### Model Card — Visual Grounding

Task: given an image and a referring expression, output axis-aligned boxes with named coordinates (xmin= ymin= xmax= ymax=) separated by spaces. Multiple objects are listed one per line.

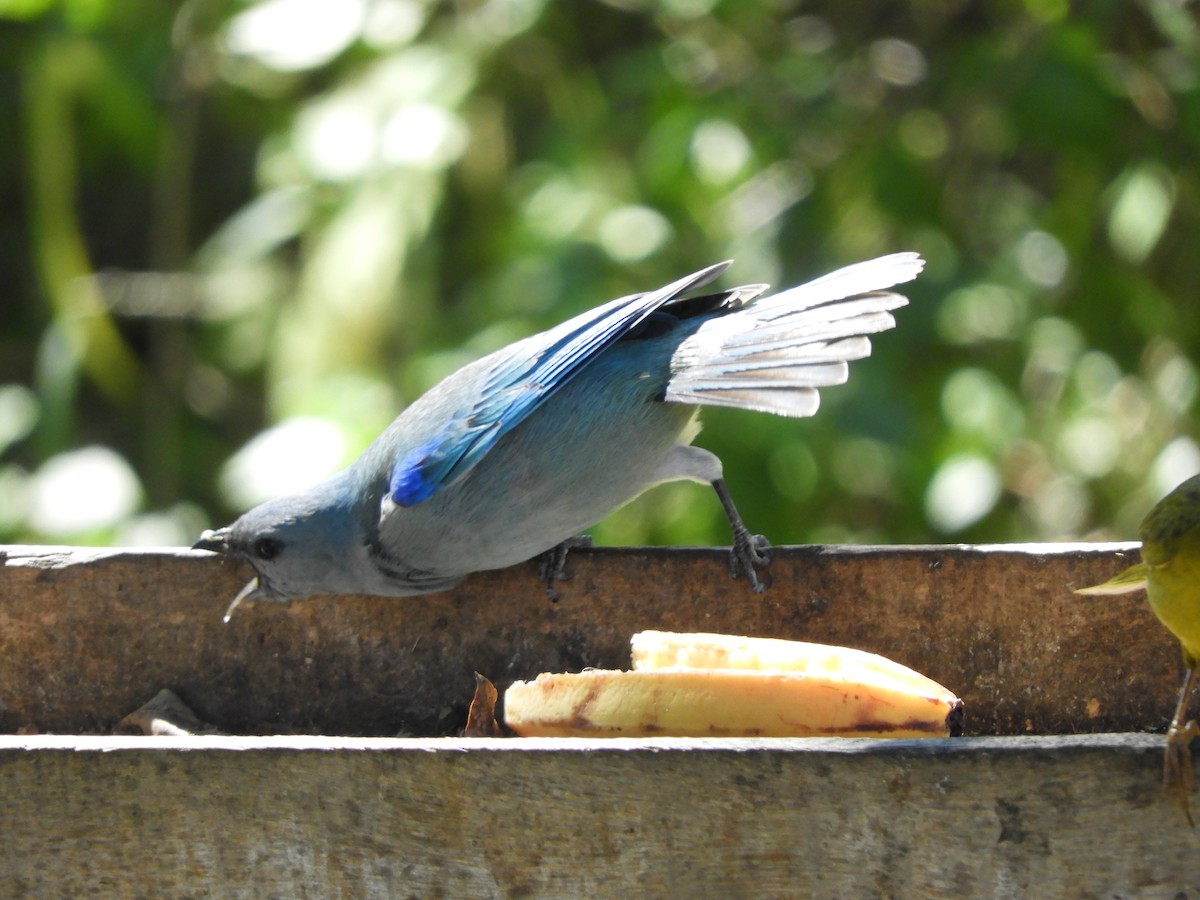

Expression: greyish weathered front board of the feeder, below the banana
xmin=0 ymin=734 xmax=1200 ymax=898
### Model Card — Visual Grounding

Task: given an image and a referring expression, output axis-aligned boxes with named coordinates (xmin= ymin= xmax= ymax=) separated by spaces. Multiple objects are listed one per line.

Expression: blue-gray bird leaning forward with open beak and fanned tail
xmin=196 ymin=253 xmax=924 ymax=611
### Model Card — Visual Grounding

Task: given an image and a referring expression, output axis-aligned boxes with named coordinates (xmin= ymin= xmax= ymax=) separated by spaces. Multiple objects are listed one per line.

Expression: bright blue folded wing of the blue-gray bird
xmin=389 ymin=263 xmax=728 ymax=506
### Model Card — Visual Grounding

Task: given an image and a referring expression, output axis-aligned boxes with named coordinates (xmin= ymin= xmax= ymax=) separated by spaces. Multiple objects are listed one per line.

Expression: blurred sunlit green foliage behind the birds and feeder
xmin=0 ymin=0 xmax=1200 ymax=545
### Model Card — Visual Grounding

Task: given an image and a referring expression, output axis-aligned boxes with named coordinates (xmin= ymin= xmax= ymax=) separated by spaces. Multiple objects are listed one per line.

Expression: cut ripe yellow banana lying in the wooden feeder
xmin=504 ymin=631 xmax=962 ymax=738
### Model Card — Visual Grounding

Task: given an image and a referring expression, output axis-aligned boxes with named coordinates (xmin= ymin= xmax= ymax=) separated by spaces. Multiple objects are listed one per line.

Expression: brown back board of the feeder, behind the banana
xmin=0 ymin=545 xmax=1178 ymax=736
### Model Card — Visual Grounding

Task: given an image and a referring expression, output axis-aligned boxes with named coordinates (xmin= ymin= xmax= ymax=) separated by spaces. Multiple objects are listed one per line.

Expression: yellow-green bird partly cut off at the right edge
xmin=1075 ymin=475 xmax=1200 ymax=827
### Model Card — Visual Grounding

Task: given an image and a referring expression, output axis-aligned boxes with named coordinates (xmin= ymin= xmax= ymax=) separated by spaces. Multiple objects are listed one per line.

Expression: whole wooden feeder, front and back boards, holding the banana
xmin=0 ymin=545 xmax=1200 ymax=898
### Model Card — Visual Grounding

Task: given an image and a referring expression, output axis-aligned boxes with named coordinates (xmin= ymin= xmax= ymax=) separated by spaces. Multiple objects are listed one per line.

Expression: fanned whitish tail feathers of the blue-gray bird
xmin=664 ymin=253 xmax=924 ymax=416
